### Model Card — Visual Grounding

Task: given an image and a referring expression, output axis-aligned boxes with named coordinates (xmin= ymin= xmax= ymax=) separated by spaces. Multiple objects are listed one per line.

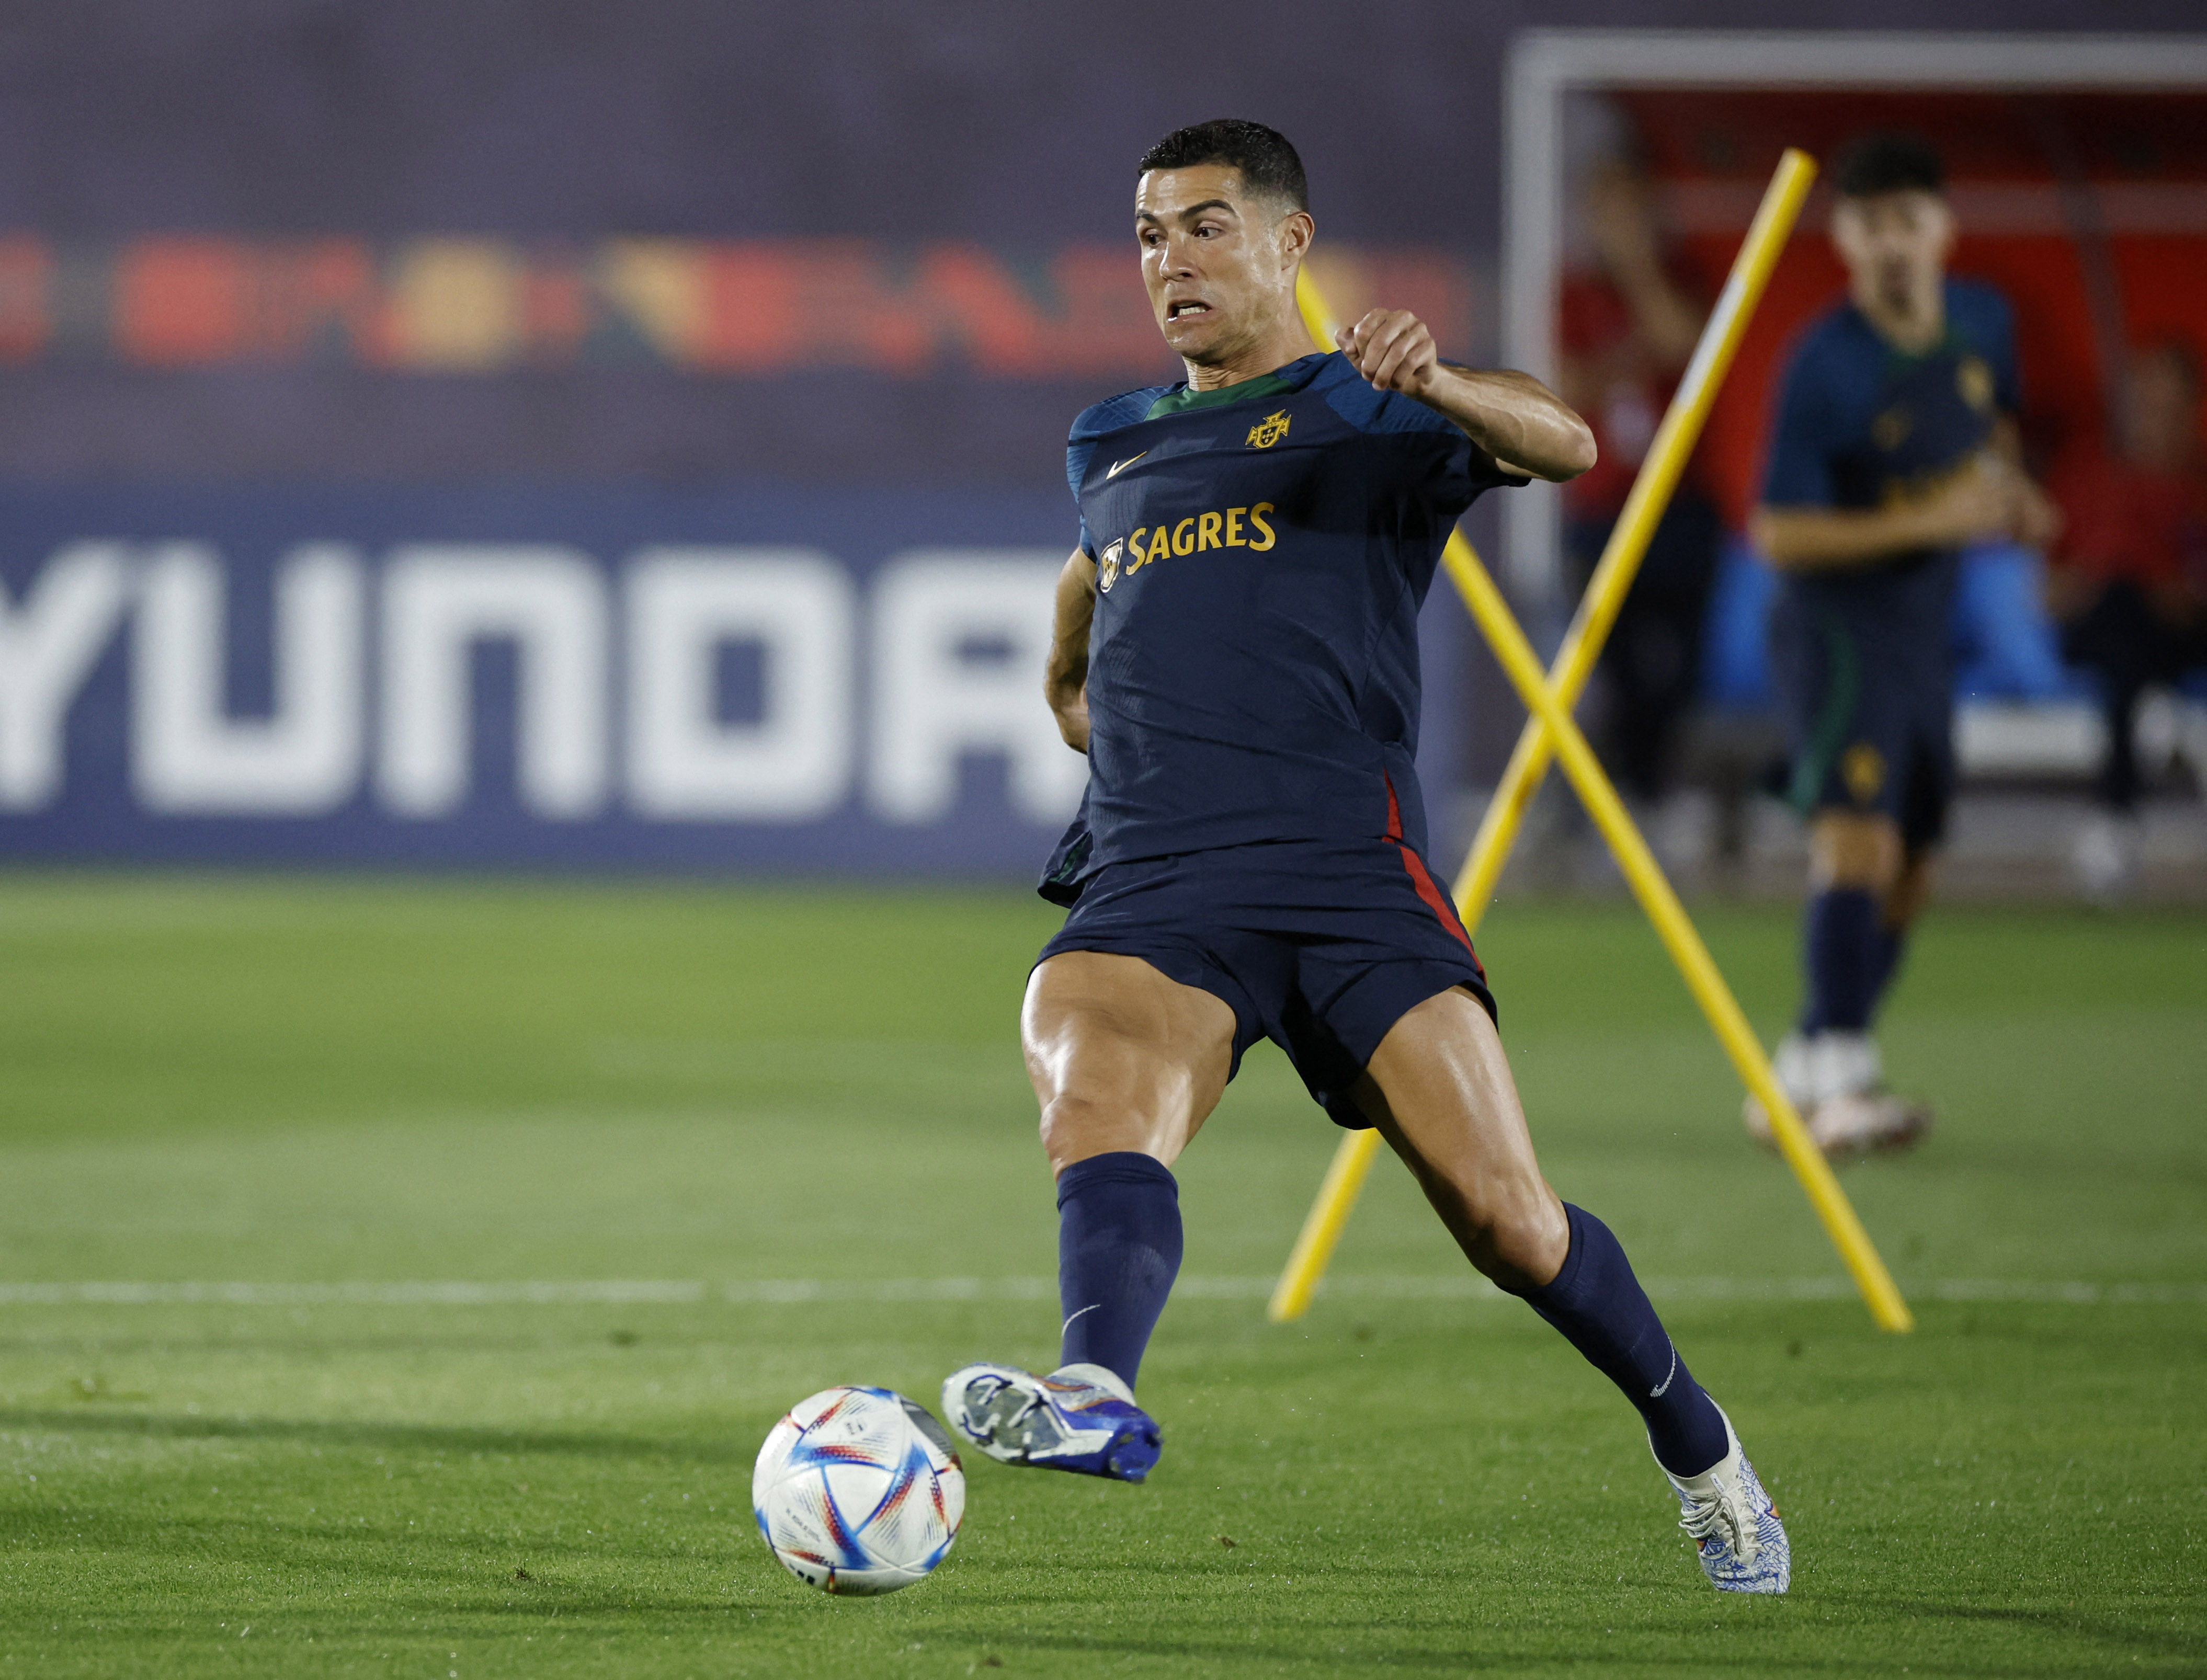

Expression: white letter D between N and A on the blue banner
xmin=624 ymin=547 xmax=854 ymax=821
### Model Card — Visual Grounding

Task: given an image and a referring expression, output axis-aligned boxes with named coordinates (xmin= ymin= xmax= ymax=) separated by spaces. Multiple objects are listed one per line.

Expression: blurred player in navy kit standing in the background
xmin=1746 ymin=135 xmax=2055 ymax=1155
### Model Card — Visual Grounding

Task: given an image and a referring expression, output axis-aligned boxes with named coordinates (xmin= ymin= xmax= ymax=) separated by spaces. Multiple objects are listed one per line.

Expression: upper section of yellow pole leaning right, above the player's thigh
xmin=1457 ymin=148 xmax=1816 ymax=927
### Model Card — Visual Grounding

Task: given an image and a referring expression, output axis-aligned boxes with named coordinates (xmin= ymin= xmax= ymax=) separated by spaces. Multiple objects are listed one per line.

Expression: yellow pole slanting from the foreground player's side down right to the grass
xmin=1443 ymin=541 xmax=1916 ymax=1331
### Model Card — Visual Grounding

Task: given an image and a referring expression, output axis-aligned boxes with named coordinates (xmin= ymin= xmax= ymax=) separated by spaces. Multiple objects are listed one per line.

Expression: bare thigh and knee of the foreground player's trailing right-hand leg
xmin=1357 ymin=989 xmax=1572 ymax=1287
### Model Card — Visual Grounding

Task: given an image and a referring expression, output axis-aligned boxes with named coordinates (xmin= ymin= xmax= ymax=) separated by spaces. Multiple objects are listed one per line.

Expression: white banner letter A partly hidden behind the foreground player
xmin=867 ymin=547 xmax=1088 ymax=824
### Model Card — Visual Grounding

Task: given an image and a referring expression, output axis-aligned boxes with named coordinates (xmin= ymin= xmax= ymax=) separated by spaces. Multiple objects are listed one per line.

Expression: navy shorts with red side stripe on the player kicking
xmin=1037 ymin=839 xmax=1494 ymax=1128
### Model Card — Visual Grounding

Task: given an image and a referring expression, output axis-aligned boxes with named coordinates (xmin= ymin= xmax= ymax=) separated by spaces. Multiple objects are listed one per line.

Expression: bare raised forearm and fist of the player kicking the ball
xmin=1342 ymin=309 xmax=1594 ymax=484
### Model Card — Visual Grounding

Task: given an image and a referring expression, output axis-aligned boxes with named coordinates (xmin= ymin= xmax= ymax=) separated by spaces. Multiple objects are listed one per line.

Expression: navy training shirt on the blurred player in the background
xmin=1764 ymin=278 xmax=2017 ymax=563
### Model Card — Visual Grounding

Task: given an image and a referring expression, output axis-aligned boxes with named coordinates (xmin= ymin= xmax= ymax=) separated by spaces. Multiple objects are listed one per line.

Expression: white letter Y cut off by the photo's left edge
xmin=0 ymin=543 xmax=130 ymax=810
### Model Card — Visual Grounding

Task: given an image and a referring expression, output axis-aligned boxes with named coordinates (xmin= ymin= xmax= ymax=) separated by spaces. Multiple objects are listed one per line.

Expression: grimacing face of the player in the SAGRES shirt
xmin=1134 ymin=163 xmax=1311 ymax=367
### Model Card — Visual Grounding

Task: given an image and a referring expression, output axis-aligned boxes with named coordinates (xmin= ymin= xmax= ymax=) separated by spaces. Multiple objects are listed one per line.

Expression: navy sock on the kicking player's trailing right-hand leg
xmin=1525 ymin=1203 xmax=1726 ymax=1477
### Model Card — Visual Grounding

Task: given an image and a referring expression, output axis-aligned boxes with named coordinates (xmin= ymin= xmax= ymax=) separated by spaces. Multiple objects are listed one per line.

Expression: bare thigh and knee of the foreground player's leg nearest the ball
xmin=1020 ymin=952 xmax=1234 ymax=1172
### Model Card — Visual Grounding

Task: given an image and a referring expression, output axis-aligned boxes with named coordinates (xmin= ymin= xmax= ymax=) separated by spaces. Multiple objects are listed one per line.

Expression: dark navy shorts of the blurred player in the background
xmin=1770 ymin=574 xmax=1955 ymax=852
